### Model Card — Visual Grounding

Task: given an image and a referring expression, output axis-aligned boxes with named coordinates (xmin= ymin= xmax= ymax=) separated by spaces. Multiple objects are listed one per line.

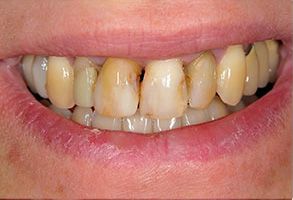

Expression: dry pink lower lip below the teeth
xmin=0 ymin=54 xmax=292 ymax=163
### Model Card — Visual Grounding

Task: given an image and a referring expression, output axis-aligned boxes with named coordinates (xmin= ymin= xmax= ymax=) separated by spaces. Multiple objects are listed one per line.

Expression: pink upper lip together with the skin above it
xmin=0 ymin=1 xmax=291 ymax=59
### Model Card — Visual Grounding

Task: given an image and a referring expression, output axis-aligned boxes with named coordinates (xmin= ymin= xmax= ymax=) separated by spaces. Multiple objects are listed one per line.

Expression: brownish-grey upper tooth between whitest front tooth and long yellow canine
xmin=185 ymin=52 xmax=217 ymax=109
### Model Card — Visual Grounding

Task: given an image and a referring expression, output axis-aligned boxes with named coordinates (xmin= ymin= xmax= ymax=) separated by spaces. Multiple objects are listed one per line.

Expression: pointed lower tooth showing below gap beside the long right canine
xmin=208 ymin=96 xmax=229 ymax=120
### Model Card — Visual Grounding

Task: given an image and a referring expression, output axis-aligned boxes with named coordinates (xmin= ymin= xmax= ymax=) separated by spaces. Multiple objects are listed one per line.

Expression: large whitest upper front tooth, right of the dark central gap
xmin=139 ymin=59 xmax=187 ymax=119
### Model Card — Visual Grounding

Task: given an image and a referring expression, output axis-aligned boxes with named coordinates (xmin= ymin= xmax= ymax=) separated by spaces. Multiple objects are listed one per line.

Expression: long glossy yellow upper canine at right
xmin=217 ymin=45 xmax=246 ymax=105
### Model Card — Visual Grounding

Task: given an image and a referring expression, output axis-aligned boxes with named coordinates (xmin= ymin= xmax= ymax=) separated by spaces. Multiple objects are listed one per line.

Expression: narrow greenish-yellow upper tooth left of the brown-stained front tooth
xmin=73 ymin=57 xmax=98 ymax=107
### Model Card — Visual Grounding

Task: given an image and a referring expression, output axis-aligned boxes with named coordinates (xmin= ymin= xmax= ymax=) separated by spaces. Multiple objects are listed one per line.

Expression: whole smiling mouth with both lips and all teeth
xmin=0 ymin=0 xmax=292 ymax=162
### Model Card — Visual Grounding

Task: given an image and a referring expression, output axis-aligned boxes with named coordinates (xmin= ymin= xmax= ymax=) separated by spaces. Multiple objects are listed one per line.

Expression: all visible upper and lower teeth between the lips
xmin=21 ymin=40 xmax=280 ymax=134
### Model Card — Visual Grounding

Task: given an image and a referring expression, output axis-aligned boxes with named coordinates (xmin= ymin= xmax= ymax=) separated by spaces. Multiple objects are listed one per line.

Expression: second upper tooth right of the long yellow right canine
xmin=254 ymin=42 xmax=270 ymax=88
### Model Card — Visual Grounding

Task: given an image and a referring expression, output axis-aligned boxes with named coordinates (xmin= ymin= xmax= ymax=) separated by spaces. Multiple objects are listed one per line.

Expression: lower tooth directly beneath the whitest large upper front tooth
xmin=153 ymin=117 xmax=181 ymax=132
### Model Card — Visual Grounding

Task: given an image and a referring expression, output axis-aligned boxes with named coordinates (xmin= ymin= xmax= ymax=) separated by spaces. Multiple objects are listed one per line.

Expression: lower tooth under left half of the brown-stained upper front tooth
xmin=92 ymin=111 xmax=122 ymax=131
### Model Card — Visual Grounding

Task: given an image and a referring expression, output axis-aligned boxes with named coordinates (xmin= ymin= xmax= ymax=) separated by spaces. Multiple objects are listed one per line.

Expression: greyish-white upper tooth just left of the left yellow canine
xmin=32 ymin=56 xmax=48 ymax=98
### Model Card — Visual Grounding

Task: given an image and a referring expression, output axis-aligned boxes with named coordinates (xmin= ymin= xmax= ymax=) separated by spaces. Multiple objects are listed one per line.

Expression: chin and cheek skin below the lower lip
xmin=0 ymin=105 xmax=292 ymax=198
